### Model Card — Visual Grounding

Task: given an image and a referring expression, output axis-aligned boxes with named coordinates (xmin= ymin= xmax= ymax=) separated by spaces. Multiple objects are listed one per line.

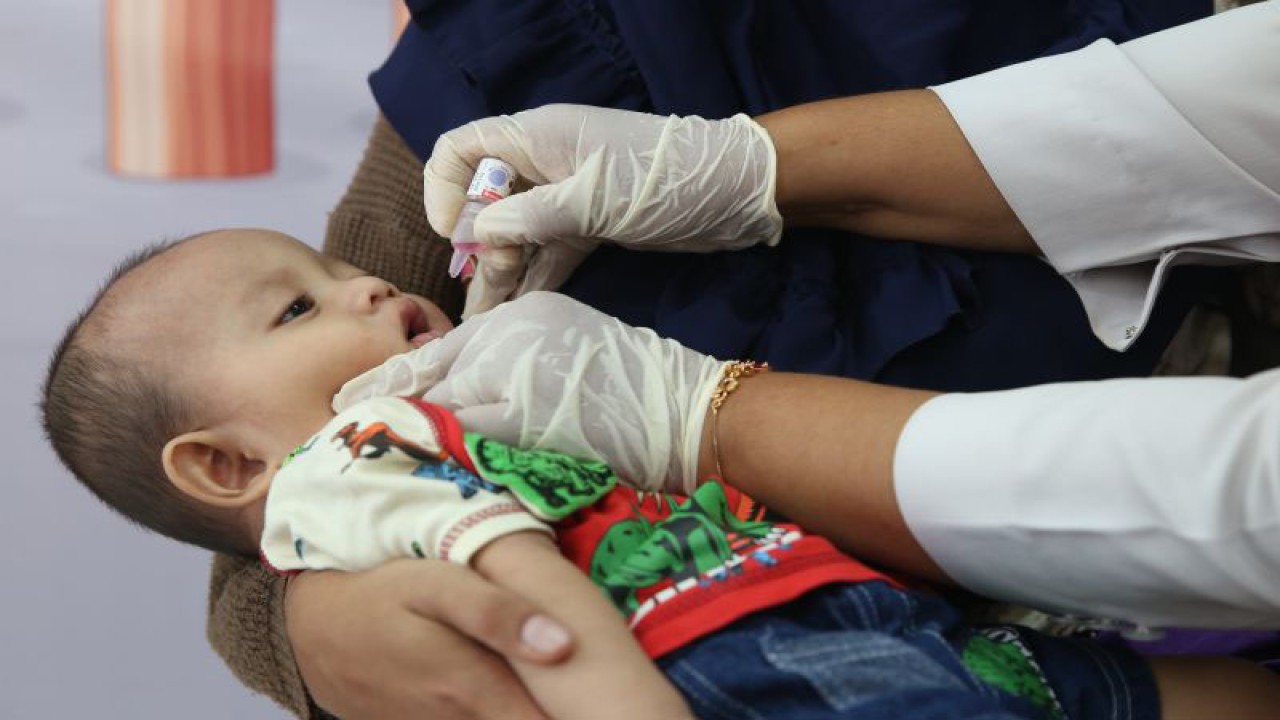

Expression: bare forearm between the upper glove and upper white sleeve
xmin=756 ymin=90 xmax=1038 ymax=252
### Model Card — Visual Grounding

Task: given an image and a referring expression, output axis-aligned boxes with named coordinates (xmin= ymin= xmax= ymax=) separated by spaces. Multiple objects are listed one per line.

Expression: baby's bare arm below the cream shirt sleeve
xmin=471 ymin=532 xmax=692 ymax=720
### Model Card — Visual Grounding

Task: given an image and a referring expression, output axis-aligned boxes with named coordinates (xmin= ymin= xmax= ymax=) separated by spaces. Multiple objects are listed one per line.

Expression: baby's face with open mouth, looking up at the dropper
xmin=134 ymin=229 xmax=453 ymax=457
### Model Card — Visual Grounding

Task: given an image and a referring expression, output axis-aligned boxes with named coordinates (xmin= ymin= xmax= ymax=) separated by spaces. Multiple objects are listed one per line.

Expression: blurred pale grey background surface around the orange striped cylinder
xmin=0 ymin=0 xmax=392 ymax=720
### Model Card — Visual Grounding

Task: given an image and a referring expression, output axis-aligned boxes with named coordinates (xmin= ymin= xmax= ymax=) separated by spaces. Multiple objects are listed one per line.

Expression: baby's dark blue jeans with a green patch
xmin=659 ymin=582 xmax=1160 ymax=720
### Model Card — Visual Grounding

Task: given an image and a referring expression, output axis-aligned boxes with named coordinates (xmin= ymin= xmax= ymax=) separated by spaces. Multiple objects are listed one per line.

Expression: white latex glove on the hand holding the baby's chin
xmin=333 ymin=292 xmax=724 ymax=492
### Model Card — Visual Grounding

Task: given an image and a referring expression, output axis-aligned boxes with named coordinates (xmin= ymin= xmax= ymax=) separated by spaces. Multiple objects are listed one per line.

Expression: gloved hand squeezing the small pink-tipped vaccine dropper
xmin=422 ymin=105 xmax=782 ymax=316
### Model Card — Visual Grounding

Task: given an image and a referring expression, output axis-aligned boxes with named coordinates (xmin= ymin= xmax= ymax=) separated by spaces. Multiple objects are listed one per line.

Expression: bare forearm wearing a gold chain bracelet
xmin=699 ymin=373 xmax=946 ymax=580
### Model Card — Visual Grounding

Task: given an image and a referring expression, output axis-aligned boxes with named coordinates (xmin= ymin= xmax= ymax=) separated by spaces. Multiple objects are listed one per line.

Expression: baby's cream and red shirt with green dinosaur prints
xmin=262 ymin=397 xmax=899 ymax=657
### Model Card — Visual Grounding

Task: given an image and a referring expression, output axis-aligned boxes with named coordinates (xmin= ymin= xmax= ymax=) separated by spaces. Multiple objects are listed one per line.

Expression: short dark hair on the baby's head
xmin=41 ymin=236 xmax=253 ymax=553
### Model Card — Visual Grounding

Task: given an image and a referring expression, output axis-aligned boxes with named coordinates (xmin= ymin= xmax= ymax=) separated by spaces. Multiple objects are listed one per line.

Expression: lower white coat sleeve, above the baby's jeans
xmin=895 ymin=370 xmax=1280 ymax=628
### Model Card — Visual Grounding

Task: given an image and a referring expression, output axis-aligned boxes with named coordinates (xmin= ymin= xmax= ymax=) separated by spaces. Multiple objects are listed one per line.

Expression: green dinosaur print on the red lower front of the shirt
xmin=591 ymin=483 xmax=773 ymax=615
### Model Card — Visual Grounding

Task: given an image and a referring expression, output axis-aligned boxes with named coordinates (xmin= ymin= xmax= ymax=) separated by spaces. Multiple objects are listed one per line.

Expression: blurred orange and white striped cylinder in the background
xmin=106 ymin=0 xmax=275 ymax=178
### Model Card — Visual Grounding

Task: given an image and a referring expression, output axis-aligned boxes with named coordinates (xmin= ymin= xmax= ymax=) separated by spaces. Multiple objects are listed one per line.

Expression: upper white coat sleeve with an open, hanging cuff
xmin=933 ymin=0 xmax=1280 ymax=350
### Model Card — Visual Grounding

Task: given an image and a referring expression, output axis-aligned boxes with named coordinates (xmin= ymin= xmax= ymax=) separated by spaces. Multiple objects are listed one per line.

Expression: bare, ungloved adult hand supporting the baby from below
xmin=285 ymin=559 xmax=572 ymax=720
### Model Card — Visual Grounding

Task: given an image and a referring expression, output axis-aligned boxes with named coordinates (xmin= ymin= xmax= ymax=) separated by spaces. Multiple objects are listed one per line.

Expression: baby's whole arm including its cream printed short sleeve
xmin=261 ymin=397 xmax=690 ymax=720
